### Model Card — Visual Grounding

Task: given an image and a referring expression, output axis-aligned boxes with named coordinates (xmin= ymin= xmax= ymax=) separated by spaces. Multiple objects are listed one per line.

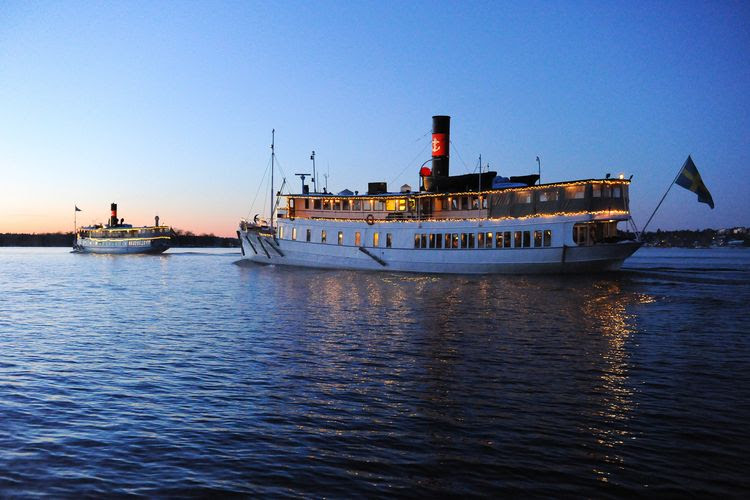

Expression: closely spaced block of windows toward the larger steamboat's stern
xmin=414 ymin=229 xmax=552 ymax=248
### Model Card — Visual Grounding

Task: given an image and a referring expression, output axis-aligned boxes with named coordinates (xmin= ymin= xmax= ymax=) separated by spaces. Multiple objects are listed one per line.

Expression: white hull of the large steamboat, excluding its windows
xmin=238 ymin=220 xmax=640 ymax=274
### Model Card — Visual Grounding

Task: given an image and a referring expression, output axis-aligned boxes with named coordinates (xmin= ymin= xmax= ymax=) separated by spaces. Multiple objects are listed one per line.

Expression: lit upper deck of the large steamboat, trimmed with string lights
xmin=279 ymin=179 xmax=630 ymax=221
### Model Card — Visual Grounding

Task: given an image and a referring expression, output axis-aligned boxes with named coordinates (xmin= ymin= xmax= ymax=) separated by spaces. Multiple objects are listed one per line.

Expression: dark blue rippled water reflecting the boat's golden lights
xmin=0 ymin=248 xmax=750 ymax=498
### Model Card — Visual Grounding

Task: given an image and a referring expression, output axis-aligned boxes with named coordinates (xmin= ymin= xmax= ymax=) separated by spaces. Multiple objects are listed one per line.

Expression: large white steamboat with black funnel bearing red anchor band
xmin=237 ymin=116 xmax=641 ymax=274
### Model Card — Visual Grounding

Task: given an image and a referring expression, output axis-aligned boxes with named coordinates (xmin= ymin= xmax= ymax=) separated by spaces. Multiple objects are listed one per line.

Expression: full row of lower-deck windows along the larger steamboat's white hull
xmin=279 ymin=226 xmax=552 ymax=248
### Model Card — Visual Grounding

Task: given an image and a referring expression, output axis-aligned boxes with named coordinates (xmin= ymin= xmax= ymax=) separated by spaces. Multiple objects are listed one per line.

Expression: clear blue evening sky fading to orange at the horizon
xmin=0 ymin=0 xmax=750 ymax=236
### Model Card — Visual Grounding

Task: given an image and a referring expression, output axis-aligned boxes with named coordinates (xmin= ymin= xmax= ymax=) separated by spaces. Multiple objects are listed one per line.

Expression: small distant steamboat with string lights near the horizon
xmin=73 ymin=203 xmax=172 ymax=254
